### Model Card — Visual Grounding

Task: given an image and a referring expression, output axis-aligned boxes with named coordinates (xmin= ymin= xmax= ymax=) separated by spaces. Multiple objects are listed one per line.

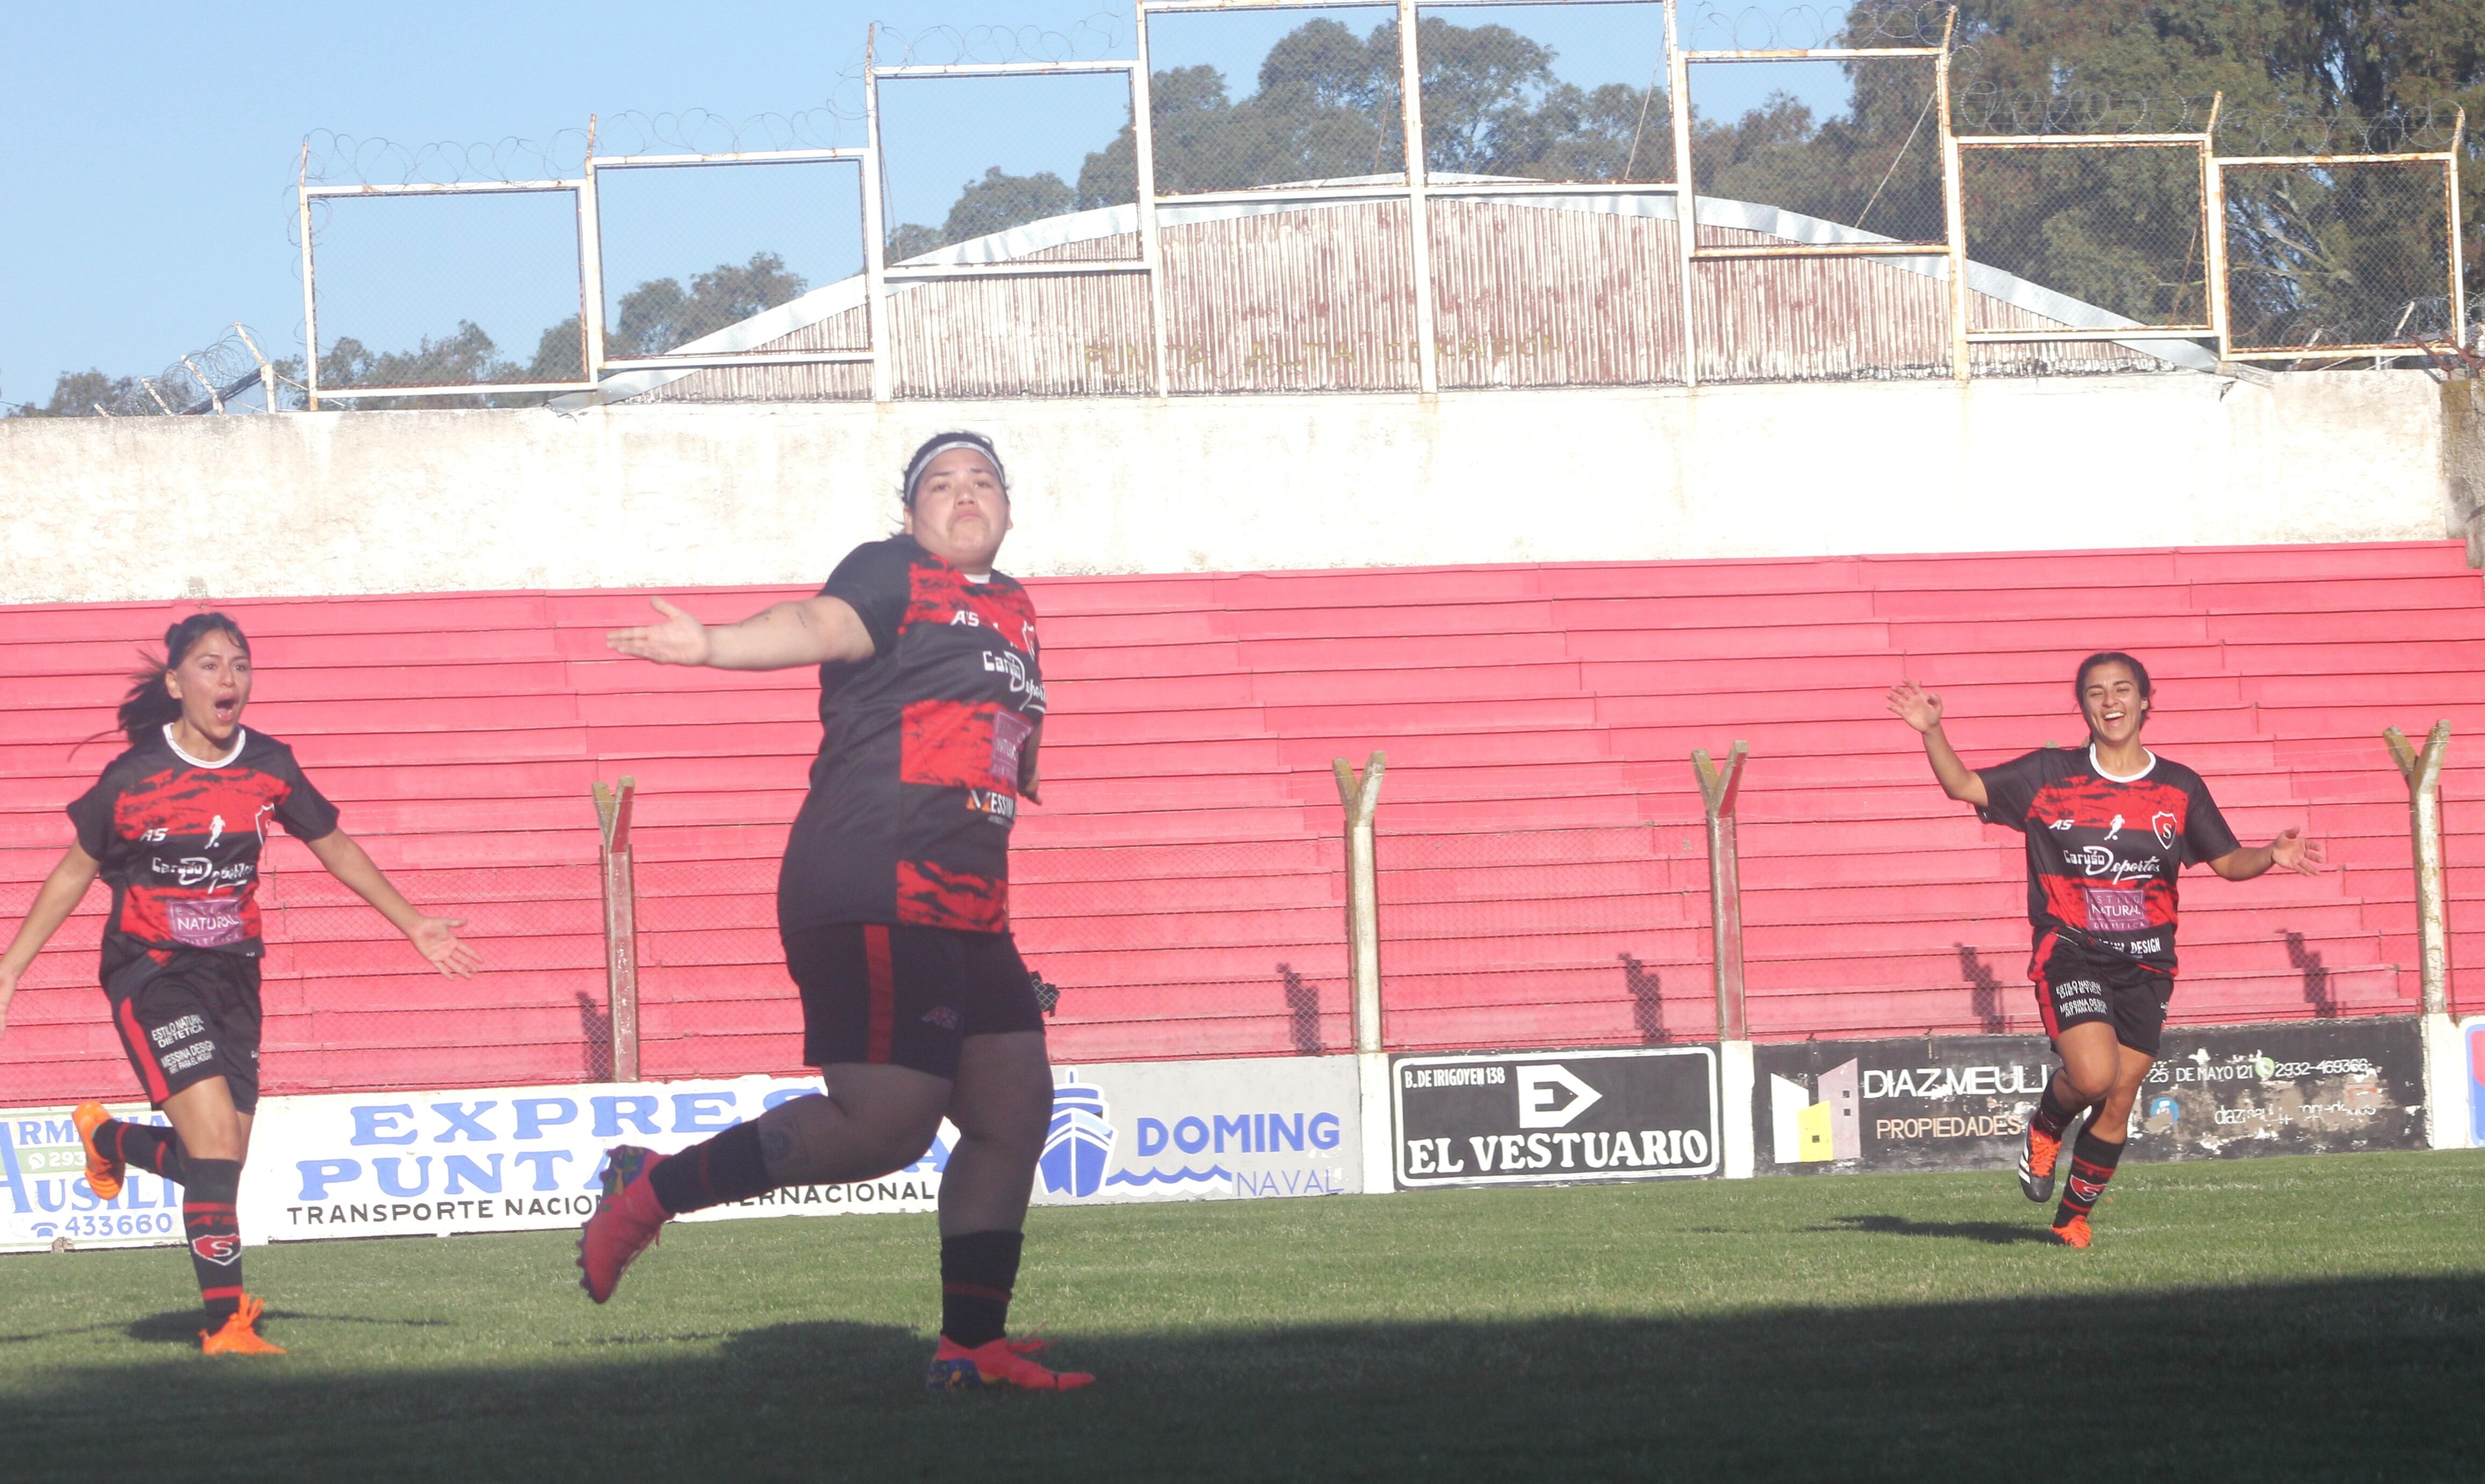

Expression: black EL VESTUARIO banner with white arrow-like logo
xmin=1389 ymin=1046 xmax=1722 ymax=1188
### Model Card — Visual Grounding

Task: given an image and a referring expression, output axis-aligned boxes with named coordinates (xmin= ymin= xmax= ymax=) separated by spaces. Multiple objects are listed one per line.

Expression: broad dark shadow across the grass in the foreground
xmin=0 ymin=1282 xmax=2485 ymax=1484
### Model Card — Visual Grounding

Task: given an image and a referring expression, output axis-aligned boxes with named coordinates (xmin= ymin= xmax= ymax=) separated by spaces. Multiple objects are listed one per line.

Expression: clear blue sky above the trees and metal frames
xmin=0 ymin=0 xmax=1839 ymax=403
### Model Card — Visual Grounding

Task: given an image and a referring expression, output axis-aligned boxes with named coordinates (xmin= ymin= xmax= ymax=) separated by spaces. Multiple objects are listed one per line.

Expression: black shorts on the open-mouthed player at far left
xmin=104 ymin=950 xmax=259 ymax=1114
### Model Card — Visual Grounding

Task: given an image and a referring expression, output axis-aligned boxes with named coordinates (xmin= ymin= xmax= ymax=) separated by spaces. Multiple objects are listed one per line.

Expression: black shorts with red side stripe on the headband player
xmin=786 ymin=922 xmax=1044 ymax=1079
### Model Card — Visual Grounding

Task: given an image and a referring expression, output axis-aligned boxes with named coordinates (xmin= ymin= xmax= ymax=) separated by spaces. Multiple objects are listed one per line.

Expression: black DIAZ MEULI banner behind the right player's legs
xmin=1752 ymin=1019 xmax=2425 ymax=1173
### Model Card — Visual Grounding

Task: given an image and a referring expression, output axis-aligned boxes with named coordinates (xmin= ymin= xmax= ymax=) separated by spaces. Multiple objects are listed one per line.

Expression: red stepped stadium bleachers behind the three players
xmin=0 ymin=542 xmax=2485 ymax=1101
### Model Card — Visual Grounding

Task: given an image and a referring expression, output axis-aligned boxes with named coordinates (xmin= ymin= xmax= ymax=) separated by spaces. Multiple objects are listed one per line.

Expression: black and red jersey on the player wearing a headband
xmin=778 ymin=537 xmax=1044 ymax=932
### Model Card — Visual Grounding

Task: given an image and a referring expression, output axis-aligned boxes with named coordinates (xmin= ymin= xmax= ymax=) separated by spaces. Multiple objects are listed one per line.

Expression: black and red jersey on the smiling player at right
xmin=1975 ymin=748 xmax=2234 ymax=974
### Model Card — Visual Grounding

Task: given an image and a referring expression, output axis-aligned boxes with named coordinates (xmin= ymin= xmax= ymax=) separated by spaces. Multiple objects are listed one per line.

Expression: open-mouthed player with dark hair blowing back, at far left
xmin=0 ymin=614 xmax=482 ymax=1355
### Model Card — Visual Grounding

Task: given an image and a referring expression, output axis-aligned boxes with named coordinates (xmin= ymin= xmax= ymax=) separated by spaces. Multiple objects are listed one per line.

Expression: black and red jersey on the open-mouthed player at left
xmin=69 ymin=728 xmax=335 ymax=974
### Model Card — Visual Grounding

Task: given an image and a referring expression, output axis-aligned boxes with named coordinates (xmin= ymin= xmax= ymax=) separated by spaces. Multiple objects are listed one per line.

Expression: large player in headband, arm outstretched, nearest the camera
xmin=579 ymin=433 xmax=1094 ymax=1389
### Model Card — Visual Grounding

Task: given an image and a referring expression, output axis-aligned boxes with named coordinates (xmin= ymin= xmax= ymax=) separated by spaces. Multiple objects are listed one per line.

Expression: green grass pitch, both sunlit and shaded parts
xmin=0 ymin=1153 xmax=2485 ymax=1481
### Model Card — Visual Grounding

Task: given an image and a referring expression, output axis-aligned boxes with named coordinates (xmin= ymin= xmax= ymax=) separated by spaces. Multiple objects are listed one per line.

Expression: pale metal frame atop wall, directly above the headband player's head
xmin=850 ymin=48 xmax=1170 ymax=403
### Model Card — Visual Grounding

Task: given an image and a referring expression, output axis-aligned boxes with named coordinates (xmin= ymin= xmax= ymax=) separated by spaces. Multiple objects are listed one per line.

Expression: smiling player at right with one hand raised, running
xmin=1889 ymin=654 xmax=2324 ymax=1248
